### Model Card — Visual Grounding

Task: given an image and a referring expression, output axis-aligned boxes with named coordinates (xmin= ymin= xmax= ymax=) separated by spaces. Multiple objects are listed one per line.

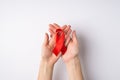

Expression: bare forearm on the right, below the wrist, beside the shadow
xmin=66 ymin=56 xmax=83 ymax=80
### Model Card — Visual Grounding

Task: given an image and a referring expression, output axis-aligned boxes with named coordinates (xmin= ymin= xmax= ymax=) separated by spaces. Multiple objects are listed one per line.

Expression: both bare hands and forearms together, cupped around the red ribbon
xmin=38 ymin=23 xmax=83 ymax=80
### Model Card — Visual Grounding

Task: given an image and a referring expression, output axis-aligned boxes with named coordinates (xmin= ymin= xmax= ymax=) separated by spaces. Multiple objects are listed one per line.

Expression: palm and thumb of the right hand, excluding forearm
xmin=62 ymin=31 xmax=79 ymax=63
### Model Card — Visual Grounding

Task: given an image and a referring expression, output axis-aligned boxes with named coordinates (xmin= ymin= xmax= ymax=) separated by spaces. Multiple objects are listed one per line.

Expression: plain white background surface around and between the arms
xmin=0 ymin=0 xmax=120 ymax=80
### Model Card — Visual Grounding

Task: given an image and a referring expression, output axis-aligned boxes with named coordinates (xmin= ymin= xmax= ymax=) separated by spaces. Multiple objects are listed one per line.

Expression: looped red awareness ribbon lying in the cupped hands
xmin=52 ymin=29 xmax=67 ymax=56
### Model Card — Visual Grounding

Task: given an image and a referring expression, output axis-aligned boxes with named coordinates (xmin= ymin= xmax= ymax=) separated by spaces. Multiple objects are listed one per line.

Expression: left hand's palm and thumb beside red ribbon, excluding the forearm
xmin=41 ymin=25 xmax=61 ymax=65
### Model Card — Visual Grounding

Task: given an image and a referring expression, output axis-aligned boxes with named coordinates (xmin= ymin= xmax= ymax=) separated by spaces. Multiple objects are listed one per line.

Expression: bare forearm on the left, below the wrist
xmin=38 ymin=60 xmax=54 ymax=80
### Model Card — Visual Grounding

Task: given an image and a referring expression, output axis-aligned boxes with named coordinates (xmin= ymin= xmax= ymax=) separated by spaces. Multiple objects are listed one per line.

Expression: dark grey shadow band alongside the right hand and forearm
xmin=77 ymin=33 xmax=92 ymax=80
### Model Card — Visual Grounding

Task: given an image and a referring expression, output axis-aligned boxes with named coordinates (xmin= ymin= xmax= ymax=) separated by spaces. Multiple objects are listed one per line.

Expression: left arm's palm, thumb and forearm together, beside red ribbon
xmin=38 ymin=30 xmax=60 ymax=80
